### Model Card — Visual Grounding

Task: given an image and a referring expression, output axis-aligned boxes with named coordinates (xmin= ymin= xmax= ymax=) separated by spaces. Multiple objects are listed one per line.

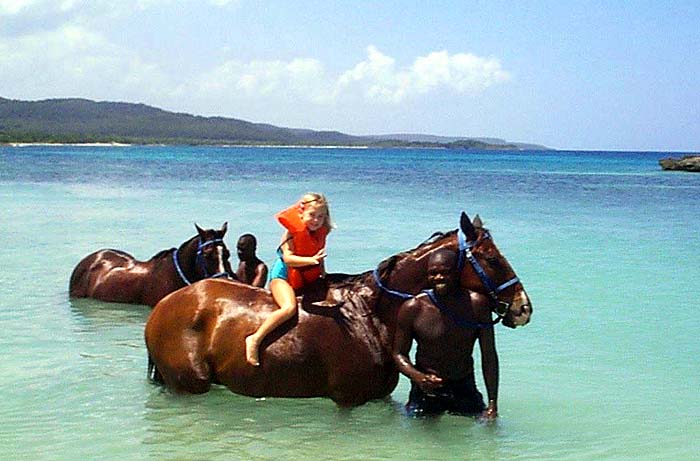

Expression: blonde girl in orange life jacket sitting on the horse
xmin=245 ymin=193 xmax=333 ymax=366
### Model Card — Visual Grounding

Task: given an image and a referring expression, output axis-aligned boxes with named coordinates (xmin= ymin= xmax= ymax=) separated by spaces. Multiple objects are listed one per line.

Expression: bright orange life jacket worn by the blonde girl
xmin=275 ymin=203 xmax=328 ymax=290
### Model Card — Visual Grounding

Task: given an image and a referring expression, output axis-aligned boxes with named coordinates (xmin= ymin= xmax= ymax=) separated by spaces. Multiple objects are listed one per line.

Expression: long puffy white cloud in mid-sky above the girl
xmin=192 ymin=46 xmax=509 ymax=104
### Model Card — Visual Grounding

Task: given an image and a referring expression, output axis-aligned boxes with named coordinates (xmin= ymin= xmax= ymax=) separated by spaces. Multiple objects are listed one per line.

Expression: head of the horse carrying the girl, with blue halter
xmin=457 ymin=212 xmax=532 ymax=328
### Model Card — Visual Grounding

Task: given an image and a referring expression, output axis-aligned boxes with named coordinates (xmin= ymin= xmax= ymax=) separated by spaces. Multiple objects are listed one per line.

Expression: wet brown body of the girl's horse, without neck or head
xmin=146 ymin=280 xmax=395 ymax=404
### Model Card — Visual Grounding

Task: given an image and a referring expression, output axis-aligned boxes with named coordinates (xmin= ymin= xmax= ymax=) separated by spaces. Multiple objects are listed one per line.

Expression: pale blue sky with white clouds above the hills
xmin=0 ymin=0 xmax=700 ymax=152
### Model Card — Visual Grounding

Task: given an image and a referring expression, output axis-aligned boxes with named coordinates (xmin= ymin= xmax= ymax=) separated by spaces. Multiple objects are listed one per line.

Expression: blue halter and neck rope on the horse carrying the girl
xmin=372 ymin=217 xmax=520 ymax=326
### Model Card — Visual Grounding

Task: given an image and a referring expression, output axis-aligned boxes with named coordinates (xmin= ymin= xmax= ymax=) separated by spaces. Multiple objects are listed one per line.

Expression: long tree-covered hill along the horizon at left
xmin=0 ymin=98 xmax=540 ymax=150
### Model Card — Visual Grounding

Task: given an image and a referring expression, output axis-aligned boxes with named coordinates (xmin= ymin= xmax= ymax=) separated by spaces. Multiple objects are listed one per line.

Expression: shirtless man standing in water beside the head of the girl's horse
xmin=393 ymin=249 xmax=498 ymax=420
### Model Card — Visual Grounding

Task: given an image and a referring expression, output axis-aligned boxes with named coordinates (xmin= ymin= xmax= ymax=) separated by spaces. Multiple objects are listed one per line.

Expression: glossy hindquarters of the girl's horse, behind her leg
xmin=145 ymin=279 xmax=273 ymax=393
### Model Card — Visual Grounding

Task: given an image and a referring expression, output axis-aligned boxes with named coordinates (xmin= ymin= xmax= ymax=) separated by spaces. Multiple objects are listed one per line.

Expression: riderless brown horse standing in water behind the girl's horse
xmin=69 ymin=223 xmax=235 ymax=306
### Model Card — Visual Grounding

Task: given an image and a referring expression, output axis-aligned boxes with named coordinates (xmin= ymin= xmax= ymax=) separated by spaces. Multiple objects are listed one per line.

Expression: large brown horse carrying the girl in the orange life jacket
xmin=145 ymin=213 xmax=532 ymax=406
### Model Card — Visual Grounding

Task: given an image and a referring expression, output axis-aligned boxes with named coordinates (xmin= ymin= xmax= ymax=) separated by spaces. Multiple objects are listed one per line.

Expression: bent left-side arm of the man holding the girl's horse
xmin=392 ymin=298 xmax=442 ymax=393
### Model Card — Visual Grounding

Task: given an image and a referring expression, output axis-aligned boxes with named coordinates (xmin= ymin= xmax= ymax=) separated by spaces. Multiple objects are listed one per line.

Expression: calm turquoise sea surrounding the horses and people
xmin=0 ymin=146 xmax=700 ymax=460
